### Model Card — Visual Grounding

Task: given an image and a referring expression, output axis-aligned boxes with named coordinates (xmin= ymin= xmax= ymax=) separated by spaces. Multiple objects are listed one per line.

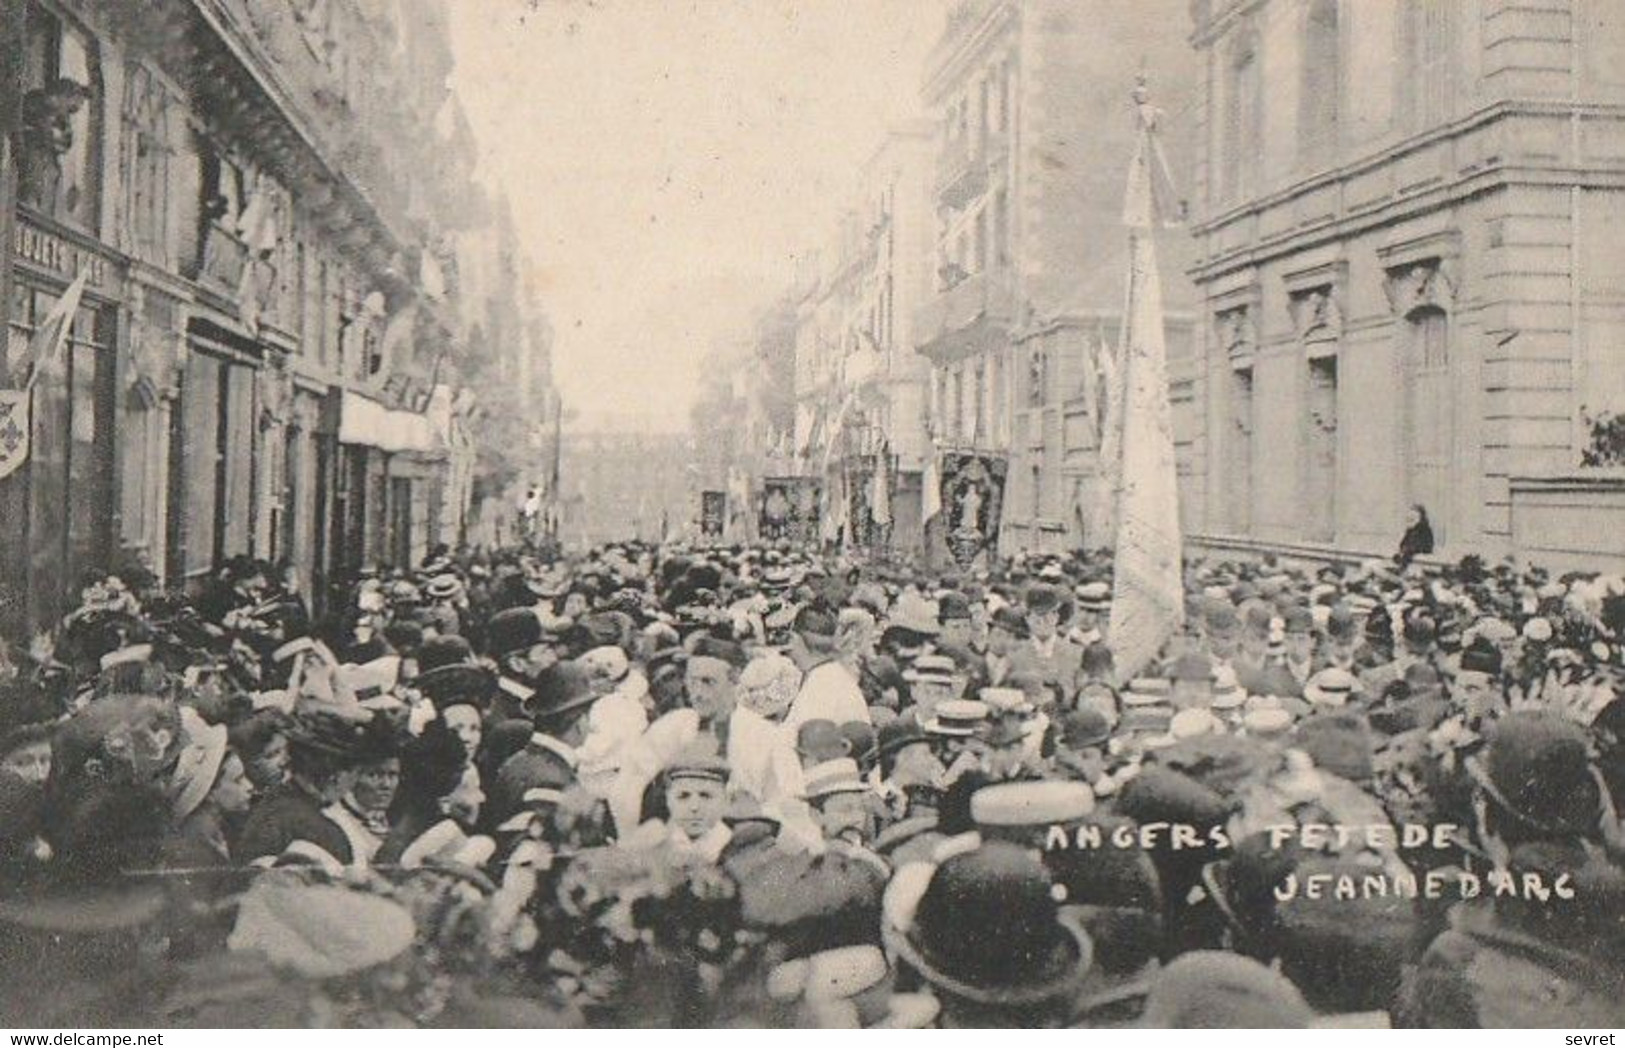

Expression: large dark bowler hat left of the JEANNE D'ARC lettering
xmin=886 ymin=842 xmax=1094 ymax=1006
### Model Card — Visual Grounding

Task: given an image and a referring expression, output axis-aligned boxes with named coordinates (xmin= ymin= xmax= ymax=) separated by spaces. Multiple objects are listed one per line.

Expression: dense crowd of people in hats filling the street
xmin=0 ymin=543 xmax=1625 ymax=1029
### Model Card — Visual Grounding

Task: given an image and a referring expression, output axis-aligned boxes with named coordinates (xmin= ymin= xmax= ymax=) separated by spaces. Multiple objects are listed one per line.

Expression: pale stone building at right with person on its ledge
xmin=1175 ymin=0 xmax=1625 ymax=567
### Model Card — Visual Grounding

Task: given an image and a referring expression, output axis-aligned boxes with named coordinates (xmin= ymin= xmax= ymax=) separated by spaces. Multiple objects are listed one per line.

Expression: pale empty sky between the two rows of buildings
xmin=447 ymin=0 xmax=947 ymax=429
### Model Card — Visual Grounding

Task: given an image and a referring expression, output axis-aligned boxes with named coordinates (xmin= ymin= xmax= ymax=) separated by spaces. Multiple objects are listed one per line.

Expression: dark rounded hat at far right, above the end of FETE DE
xmin=1466 ymin=712 xmax=1602 ymax=837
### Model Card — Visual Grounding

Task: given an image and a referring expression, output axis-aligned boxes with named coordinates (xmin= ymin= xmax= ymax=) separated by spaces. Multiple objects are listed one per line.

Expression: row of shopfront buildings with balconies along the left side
xmin=0 ymin=0 xmax=546 ymax=634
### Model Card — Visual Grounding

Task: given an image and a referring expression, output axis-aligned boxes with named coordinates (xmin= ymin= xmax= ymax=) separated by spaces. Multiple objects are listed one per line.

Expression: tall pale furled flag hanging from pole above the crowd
xmin=1108 ymin=78 xmax=1185 ymax=679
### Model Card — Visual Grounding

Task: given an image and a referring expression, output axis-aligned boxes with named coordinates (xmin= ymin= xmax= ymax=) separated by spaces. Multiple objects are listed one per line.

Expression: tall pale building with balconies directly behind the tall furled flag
xmin=915 ymin=0 xmax=1193 ymax=551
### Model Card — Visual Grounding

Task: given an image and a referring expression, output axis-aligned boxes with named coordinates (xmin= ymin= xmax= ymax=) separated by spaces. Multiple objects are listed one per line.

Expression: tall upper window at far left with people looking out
xmin=16 ymin=3 xmax=101 ymax=231
